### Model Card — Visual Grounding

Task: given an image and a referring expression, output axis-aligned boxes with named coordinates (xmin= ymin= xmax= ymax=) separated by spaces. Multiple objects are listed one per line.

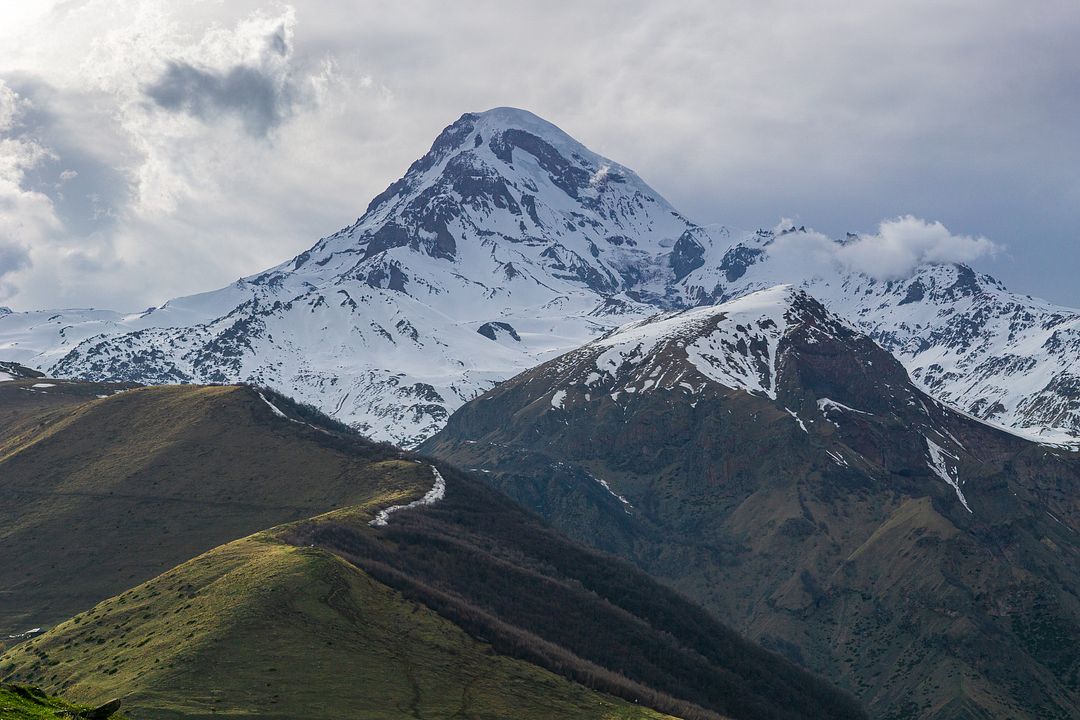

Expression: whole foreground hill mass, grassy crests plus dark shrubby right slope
xmin=0 ymin=379 xmax=864 ymax=720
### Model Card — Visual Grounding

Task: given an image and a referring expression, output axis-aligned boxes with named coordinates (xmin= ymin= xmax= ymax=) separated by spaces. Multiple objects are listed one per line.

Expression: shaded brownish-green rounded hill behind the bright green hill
xmin=0 ymin=380 xmax=416 ymax=637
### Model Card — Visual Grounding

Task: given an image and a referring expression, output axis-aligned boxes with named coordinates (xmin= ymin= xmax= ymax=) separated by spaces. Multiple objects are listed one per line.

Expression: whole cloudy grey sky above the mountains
xmin=0 ymin=0 xmax=1080 ymax=310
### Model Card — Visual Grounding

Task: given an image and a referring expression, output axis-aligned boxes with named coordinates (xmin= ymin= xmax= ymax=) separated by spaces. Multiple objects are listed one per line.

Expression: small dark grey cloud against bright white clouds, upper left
xmin=146 ymin=60 xmax=293 ymax=137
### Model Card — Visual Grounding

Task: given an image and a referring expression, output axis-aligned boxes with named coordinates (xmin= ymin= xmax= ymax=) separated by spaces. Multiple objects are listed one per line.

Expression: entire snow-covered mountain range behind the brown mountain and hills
xmin=0 ymin=108 xmax=1080 ymax=446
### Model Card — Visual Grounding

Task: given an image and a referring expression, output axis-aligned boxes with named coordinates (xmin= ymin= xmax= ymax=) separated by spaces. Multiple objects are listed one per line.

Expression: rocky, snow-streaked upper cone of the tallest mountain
xmin=275 ymin=108 xmax=708 ymax=302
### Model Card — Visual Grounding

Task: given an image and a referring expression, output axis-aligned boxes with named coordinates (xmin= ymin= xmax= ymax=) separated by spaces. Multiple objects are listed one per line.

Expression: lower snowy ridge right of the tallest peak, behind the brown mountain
xmin=683 ymin=228 xmax=1080 ymax=444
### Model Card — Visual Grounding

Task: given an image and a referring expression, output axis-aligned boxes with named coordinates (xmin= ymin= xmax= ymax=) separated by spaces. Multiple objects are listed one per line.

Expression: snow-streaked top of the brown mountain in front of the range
xmin=477 ymin=285 xmax=993 ymax=513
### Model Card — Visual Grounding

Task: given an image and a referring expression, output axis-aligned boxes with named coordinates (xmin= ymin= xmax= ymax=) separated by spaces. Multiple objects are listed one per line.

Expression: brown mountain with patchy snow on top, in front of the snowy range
xmin=423 ymin=286 xmax=1080 ymax=720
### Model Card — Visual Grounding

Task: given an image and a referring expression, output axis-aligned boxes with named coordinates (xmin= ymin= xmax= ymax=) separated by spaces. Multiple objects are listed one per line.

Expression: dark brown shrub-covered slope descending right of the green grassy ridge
xmin=285 ymin=466 xmax=865 ymax=720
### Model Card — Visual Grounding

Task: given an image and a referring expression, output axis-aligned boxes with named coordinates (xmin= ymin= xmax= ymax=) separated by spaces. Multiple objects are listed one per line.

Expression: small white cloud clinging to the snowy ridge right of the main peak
xmin=769 ymin=215 xmax=1003 ymax=280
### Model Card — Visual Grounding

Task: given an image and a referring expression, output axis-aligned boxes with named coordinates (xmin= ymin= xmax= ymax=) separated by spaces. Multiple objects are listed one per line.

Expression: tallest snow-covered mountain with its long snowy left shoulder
xmin=0 ymin=108 xmax=712 ymax=445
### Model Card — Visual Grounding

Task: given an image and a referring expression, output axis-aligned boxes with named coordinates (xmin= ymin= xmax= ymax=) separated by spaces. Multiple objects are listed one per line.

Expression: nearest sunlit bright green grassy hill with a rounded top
xmin=0 ymin=533 xmax=665 ymax=720
